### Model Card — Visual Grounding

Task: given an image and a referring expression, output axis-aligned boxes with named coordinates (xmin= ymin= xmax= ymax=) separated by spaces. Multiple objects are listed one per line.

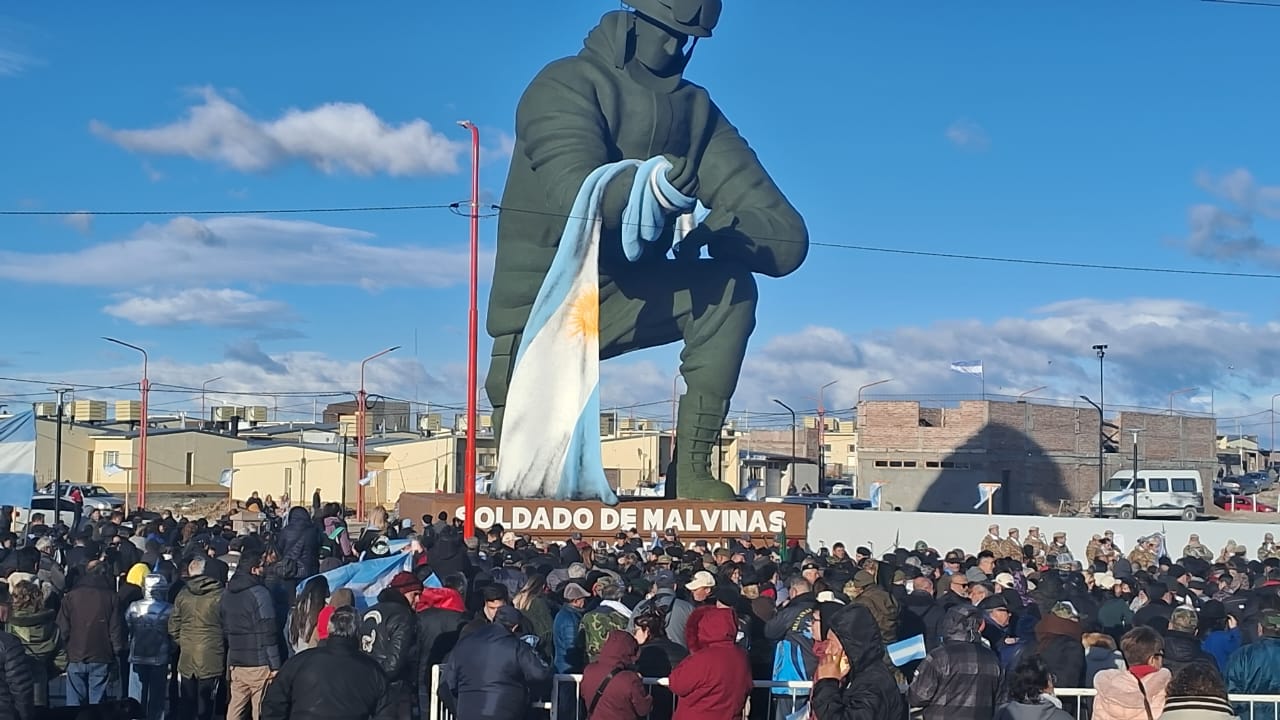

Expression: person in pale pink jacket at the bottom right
xmin=1092 ymin=625 xmax=1172 ymax=720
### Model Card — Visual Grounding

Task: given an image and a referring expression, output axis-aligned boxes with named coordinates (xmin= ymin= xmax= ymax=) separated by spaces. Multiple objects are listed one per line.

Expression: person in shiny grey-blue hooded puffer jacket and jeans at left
xmin=124 ymin=573 xmax=174 ymax=720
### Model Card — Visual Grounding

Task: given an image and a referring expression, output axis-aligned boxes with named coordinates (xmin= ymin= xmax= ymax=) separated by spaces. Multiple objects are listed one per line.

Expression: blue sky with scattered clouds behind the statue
xmin=0 ymin=0 xmax=1280 ymax=432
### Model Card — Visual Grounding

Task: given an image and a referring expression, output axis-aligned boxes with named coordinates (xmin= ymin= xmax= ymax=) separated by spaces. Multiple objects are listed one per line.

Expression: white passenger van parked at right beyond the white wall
xmin=1089 ymin=470 xmax=1204 ymax=520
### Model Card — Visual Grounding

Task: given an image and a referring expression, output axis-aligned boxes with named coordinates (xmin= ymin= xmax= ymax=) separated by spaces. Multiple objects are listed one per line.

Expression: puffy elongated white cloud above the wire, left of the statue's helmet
xmin=90 ymin=87 xmax=466 ymax=176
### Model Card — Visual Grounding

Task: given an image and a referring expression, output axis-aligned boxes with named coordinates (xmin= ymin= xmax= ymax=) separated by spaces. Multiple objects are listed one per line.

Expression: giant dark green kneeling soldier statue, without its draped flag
xmin=485 ymin=0 xmax=809 ymax=500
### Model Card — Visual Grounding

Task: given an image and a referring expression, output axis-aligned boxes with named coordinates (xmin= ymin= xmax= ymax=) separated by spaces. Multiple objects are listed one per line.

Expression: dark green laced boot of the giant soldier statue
xmin=676 ymin=391 xmax=736 ymax=500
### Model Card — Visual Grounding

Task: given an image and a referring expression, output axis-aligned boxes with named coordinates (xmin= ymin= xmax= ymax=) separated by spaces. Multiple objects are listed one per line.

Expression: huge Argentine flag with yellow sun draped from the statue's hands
xmin=490 ymin=156 xmax=705 ymax=505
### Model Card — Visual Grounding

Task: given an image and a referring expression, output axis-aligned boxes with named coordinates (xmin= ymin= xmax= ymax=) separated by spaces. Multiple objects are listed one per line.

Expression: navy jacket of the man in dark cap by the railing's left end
xmin=438 ymin=624 xmax=552 ymax=720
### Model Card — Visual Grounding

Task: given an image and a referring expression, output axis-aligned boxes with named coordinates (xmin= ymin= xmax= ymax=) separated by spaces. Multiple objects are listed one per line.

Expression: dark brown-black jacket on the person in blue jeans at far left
xmin=58 ymin=571 xmax=127 ymax=662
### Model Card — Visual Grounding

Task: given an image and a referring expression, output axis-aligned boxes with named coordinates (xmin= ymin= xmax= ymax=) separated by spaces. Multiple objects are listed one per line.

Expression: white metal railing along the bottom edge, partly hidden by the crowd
xmin=425 ymin=665 xmax=1280 ymax=720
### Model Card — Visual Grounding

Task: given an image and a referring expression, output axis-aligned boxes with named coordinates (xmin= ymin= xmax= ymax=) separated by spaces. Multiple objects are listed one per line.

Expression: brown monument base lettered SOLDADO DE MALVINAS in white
xmin=399 ymin=492 xmax=809 ymax=543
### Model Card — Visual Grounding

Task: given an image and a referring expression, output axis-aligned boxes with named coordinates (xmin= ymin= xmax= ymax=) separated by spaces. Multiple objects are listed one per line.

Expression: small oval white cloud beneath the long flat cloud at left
xmin=104 ymin=288 xmax=292 ymax=328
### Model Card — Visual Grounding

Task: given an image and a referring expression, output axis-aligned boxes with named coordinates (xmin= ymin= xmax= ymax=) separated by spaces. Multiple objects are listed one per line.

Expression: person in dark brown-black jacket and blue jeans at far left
xmin=58 ymin=560 xmax=127 ymax=706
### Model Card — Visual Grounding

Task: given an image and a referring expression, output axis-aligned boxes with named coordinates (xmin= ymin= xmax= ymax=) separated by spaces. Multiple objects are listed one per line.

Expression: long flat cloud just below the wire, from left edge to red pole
xmin=0 ymin=217 xmax=478 ymax=288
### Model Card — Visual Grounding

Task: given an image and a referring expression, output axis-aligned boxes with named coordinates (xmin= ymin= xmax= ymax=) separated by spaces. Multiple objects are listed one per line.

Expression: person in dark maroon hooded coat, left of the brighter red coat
xmin=579 ymin=630 xmax=653 ymax=720
